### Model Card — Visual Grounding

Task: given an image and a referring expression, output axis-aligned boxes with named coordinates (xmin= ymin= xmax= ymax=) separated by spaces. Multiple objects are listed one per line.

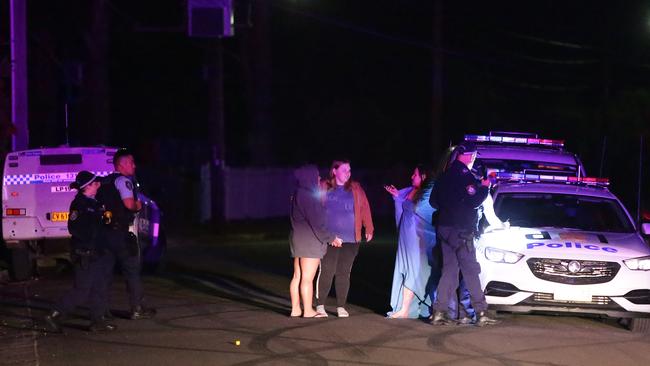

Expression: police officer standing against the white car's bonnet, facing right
xmin=430 ymin=141 xmax=497 ymax=326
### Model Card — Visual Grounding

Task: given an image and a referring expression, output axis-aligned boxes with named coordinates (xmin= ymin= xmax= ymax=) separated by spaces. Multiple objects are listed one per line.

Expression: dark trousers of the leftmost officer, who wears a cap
xmin=54 ymin=253 xmax=113 ymax=321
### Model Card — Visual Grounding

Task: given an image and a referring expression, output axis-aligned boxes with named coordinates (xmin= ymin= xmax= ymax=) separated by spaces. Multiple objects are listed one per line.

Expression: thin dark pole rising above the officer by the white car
xmin=431 ymin=0 xmax=444 ymax=157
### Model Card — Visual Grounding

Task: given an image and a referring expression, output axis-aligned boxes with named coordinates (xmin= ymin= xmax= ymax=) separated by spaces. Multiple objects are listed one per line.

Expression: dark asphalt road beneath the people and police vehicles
xmin=0 ymin=227 xmax=650 ymax=366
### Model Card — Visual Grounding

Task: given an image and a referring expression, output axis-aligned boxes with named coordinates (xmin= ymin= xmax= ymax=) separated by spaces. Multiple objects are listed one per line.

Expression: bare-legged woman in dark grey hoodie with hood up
xmin=289 ymin=165 xmax=342 ymax=318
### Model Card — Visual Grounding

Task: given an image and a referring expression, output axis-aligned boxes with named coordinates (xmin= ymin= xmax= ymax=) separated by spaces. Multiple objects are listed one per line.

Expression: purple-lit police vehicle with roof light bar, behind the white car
xmin=465 ymin=131 xmax=586 ymax=176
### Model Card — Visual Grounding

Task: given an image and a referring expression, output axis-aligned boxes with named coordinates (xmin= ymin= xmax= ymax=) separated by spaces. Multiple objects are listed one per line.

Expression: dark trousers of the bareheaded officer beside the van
xmin=106 ymin=229 xmax=143 ymax=310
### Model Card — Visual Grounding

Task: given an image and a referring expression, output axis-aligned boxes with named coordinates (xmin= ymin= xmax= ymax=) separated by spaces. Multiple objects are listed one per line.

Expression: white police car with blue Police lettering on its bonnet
xmin=476 ymin=173 xmax=650 ymax=332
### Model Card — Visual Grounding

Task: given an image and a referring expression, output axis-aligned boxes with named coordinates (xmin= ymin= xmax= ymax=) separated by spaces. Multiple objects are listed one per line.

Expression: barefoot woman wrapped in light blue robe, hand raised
xmin=385 ymin=166 xmax=440 ymax=318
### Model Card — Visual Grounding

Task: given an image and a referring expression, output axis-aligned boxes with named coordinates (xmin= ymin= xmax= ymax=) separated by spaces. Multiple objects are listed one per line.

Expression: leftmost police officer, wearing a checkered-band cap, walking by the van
xmin=45 ymin=171 xmax=116 ymax=332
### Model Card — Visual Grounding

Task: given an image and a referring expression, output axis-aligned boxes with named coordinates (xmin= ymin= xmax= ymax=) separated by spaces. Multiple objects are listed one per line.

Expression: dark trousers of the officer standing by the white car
xmin=434 ymin=226 xmax=487 ymax=312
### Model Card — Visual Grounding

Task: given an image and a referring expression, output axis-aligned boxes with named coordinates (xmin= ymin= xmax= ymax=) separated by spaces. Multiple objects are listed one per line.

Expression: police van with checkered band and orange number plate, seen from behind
xmin=2 ymin=147 xmax=166 ymax=280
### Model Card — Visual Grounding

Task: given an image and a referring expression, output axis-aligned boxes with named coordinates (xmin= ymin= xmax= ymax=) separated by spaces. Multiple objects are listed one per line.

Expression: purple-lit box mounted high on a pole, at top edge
xmin=187 ymin=0 xmax=235 ymax=38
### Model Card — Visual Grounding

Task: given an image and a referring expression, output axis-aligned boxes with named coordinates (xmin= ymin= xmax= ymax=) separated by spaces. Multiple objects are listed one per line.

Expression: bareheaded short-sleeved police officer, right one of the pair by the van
xmin=97 ymin=149 xmax=155 ymax=320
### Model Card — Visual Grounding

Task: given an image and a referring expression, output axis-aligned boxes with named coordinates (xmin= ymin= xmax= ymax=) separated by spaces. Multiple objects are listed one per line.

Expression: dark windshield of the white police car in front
xmin=494 ymin=193 xmax=634 ymax=233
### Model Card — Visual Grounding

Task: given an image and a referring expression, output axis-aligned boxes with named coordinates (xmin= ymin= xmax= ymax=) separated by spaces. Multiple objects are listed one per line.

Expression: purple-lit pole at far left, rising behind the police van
xmin=9 ymin=0 xmax=29 ymax=151
